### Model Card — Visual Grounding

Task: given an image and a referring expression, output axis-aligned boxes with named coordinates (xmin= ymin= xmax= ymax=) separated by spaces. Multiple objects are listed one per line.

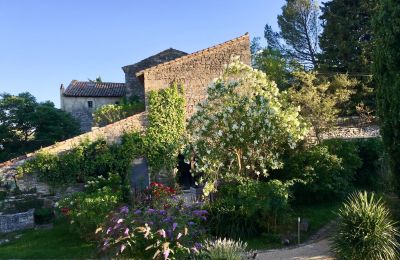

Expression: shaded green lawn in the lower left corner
xmin=0 ymin=219 xmax=95 ymax=259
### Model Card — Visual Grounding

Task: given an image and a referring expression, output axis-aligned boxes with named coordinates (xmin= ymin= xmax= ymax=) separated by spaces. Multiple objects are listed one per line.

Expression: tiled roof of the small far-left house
xmin=64 ymin=80 xmax=126 ymax=97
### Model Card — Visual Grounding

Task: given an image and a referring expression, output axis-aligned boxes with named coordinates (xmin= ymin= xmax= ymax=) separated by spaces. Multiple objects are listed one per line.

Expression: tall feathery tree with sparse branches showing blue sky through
xmin=276 ymin=0 xmax=320 ymax=67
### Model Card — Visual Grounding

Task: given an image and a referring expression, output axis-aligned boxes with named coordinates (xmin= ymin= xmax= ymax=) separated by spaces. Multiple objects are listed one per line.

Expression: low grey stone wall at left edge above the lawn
xmin=0 ymin=209 xmax=35 ymax=233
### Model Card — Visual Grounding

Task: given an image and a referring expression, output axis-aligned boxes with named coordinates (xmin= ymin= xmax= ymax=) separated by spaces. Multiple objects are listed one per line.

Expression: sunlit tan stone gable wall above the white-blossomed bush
xmin=139 ymin=34 xmax=251 ymax=116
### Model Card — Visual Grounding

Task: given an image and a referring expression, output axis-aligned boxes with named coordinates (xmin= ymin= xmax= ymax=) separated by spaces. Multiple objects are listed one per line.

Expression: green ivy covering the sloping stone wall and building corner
xmin=18 ymin=85 xmax=185 ymax=187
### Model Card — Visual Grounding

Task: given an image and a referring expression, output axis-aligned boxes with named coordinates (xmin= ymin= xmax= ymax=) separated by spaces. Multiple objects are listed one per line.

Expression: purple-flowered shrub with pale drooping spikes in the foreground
xmin=97 ymin=202 xmax=208 ymax=259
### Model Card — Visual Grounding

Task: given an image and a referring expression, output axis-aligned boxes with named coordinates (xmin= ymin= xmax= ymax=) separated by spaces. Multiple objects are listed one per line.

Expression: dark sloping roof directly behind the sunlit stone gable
xmin=122 ymin=48 xmax=187 ymax=72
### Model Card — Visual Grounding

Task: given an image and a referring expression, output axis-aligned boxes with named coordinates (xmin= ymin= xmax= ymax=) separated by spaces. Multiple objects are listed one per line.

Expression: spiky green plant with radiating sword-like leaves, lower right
xmin=333 ymin=192 xmax=400 ymax=260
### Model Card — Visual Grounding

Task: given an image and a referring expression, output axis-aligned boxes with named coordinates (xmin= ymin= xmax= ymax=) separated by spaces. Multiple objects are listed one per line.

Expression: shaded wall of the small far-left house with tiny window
xmin=61 ymin=96 xmax=121 ymax=132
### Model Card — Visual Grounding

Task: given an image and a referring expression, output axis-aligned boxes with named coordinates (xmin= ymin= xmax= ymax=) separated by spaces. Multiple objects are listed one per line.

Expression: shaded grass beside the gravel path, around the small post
xmin=245 ymin=202 xmax=341 ymax=250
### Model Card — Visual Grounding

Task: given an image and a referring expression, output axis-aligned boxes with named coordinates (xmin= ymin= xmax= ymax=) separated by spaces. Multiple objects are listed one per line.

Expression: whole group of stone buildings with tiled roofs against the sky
xmin=61 ymin=33 xmax=251 ymax=131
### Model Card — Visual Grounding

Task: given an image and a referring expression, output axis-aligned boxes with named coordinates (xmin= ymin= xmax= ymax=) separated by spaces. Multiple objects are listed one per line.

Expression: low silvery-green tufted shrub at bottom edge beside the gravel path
xmin=200 ymin=238 xmax=247 ymax=260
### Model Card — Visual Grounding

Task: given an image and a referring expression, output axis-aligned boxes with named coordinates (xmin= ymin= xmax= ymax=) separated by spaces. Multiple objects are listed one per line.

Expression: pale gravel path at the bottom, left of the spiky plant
xmin=256 ymin=239 xmax=334 ymax=260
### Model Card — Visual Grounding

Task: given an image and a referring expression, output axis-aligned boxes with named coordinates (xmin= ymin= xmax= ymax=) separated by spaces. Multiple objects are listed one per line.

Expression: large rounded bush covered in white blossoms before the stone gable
xmin=184 ymin=58 xmax=308 ymax=191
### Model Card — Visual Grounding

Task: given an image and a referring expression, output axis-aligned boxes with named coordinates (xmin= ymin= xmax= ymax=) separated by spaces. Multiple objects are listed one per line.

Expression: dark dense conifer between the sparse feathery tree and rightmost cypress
xmin=318 ymin=0 xmax=377 ymax=114
